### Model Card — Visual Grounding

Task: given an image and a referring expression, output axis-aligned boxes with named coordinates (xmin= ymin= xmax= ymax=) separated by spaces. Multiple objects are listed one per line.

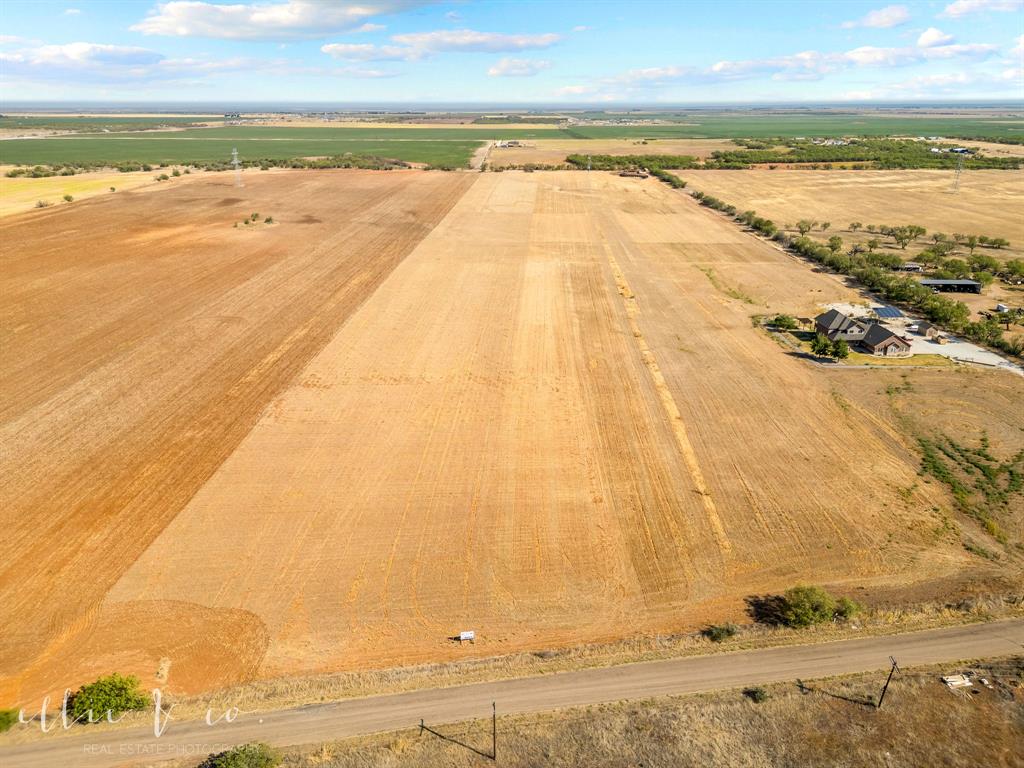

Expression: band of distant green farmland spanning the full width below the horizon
xmin=0 ymin=114 xmax=1024 ymax=166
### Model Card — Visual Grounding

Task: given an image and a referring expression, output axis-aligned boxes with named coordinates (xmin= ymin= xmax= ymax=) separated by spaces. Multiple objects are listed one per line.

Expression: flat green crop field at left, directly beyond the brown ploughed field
xmin=0 ymin=134 xmax=480 ymax=166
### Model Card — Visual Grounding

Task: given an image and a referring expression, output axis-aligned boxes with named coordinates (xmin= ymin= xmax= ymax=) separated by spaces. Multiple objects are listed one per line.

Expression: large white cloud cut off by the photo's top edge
xmin=131 ymin=0 xmax=420 ymax=40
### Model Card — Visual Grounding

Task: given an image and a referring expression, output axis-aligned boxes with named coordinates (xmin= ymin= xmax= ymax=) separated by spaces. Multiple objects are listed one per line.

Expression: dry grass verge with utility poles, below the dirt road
xmin=264 ymin=657 xmax=1024 ymax=768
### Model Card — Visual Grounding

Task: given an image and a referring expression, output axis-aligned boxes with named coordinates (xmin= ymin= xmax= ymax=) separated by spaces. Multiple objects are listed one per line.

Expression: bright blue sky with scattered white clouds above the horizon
xmin=0 ymin=0 xmax=1024 ymax=104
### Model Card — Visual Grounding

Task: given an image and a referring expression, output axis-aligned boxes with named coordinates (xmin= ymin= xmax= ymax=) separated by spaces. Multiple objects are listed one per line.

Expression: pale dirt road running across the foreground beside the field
xmin=0 ymin=620 xmax=1024 ymax=768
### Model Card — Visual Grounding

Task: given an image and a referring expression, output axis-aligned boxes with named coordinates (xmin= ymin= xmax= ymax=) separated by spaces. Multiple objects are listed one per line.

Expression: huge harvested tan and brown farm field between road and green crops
xmin=0 ymin=171 xmax=1024 ymax=702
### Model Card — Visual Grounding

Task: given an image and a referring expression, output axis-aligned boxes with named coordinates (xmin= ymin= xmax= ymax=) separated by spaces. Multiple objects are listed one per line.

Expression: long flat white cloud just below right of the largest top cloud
xmin=321 ymin=30 xmax=561 ymax=61
